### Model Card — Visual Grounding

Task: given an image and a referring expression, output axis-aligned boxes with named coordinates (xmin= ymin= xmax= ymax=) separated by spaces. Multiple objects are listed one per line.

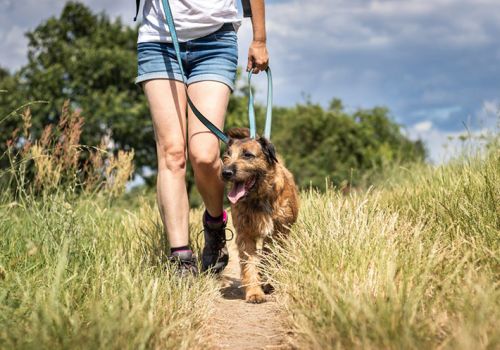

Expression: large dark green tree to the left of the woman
xmin=0 ymin=2 xmax=151 ymax=174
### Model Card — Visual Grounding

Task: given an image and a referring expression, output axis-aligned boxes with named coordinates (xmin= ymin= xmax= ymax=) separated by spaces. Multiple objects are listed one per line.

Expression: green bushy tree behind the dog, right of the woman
xmin=273 ymin=99 xmax=425 ymax=188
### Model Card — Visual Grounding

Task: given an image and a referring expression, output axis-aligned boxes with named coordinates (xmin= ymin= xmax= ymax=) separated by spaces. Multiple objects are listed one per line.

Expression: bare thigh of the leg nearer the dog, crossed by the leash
xmin=188 ymin=81 xmax=231 ymax=157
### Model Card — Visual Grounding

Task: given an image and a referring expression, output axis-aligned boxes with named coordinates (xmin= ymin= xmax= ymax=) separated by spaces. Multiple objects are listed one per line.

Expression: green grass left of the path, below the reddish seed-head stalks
xmin=0 ymin=194 xmax=217 ymax=349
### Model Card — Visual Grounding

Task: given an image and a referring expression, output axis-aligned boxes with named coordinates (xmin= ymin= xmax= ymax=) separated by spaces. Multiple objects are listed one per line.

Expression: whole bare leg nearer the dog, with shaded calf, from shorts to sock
xmin=188 ymin=81 xmax=231 ymax=216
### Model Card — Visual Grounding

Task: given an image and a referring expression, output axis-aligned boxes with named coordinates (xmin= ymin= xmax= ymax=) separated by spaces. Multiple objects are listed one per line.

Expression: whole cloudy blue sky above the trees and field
xmin=0 ymin=0 xmax=500 ymax=162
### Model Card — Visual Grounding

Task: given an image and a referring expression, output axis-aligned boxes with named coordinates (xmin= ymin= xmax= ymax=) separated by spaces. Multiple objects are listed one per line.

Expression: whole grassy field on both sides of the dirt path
xmin=0 ymin=113 xmax=500 ymax=349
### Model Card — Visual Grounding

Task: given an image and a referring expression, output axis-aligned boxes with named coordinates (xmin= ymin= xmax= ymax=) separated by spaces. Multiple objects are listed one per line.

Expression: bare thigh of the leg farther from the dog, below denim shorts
xmin=143 ymin=79 xmax=186 ymax=151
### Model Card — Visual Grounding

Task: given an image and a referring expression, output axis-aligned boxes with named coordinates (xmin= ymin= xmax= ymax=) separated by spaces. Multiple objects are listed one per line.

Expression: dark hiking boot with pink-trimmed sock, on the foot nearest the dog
xmin=201 ymin=211 xmax=232 ymax=274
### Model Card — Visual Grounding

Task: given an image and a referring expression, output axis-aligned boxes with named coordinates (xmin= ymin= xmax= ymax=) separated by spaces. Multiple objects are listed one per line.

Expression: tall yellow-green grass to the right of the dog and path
xmin=273 ymin=147 xmax=500 ymax=349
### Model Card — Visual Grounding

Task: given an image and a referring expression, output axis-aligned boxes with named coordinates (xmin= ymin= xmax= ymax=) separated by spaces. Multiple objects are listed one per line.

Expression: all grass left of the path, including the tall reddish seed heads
xmin=0 ymin=104 xmax=218 ymax=349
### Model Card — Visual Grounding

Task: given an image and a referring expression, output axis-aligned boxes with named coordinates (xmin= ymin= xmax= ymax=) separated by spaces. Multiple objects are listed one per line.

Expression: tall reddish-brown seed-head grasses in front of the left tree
xmin=0 ymin=101 xmax=134 ymax=198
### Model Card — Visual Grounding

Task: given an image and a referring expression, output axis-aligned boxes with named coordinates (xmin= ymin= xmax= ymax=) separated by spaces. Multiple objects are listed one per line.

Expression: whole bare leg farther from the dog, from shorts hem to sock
xmin=143 ymin=79 xmax=189 ymax=247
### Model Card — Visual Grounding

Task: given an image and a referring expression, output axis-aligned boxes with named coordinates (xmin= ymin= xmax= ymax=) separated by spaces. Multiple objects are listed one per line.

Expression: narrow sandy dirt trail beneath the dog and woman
xmin=207 ymin=240 xmax=292 ymax=349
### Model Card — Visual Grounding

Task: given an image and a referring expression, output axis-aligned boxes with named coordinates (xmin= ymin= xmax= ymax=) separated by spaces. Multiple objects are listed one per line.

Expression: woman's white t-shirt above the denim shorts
xmin=137 ymin=0 xmax=241 ymax=43
